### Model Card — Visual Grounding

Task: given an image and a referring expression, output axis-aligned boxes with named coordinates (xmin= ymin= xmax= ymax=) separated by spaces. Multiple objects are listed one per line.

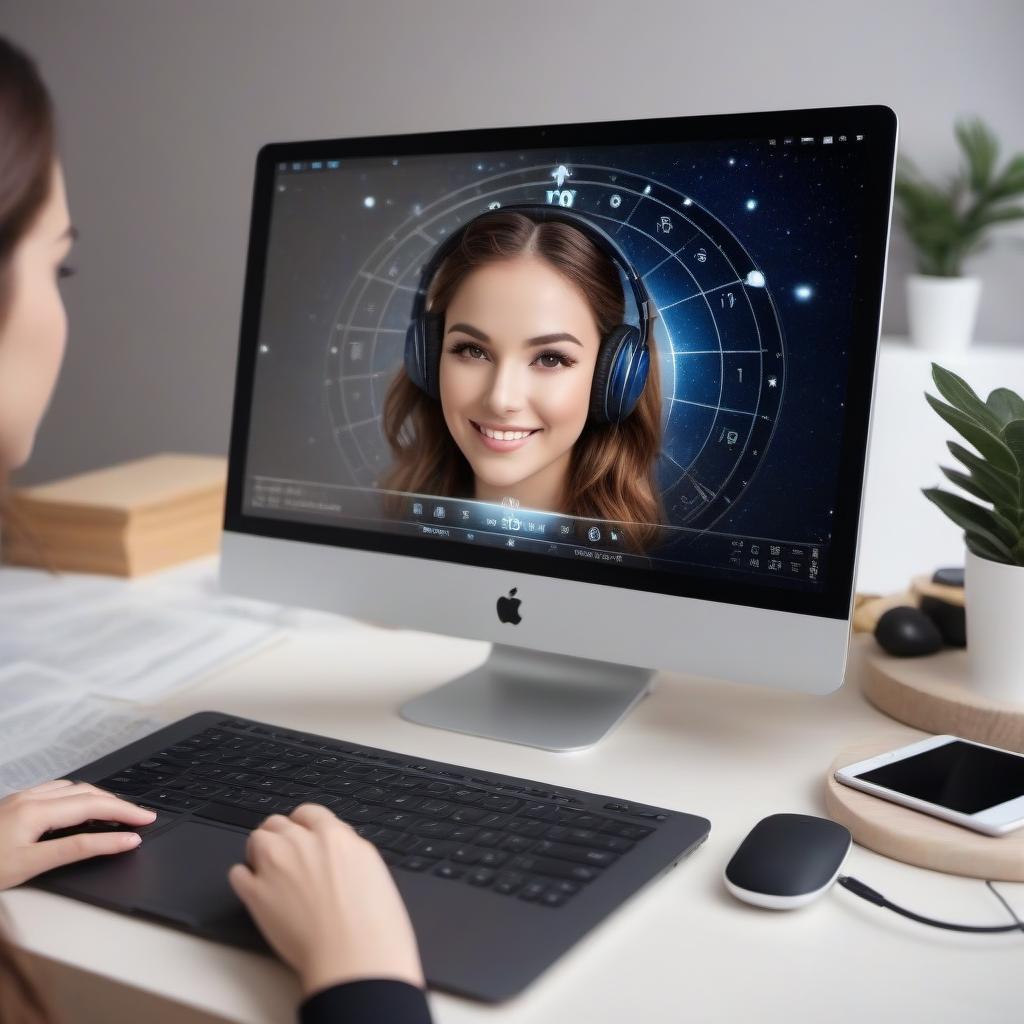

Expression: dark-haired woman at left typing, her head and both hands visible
xmin=0 ymin=37 xmax=430 ymax=1024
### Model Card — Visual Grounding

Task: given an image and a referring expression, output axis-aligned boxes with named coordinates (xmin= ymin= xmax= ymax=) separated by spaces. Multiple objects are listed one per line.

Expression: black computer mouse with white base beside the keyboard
xmin=725 ymin=814 xmax=853 ymax=910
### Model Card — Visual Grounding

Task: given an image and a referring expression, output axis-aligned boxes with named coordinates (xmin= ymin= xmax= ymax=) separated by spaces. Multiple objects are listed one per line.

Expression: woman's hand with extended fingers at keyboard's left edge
xmin=0 ymin=778 xmax=157 ymax=890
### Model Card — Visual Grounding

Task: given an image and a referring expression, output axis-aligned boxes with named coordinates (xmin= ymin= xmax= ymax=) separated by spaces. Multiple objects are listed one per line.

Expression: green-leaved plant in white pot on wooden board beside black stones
xmin=925 ymin=362 xmax=1024 ymax=703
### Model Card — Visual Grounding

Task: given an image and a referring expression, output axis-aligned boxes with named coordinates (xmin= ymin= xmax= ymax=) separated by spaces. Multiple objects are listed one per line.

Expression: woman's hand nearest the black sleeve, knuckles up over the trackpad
xmin=227 ymin=804 xmax=424 ymax=995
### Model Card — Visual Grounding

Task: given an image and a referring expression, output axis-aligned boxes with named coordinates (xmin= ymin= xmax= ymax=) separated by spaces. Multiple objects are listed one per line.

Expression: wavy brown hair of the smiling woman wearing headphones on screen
xmin=380 ymin=210 xmax=662 ymax=547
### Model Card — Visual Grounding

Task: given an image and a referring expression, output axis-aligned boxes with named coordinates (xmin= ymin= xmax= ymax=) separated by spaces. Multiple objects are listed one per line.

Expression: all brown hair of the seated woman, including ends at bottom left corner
xmin=0 ymin=36 xmax=55 ymax=1024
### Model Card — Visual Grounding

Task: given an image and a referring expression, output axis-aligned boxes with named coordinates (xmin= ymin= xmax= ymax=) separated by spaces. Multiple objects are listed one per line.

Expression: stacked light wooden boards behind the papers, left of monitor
xmin=2 ymin=455 xmax=227 ymax=577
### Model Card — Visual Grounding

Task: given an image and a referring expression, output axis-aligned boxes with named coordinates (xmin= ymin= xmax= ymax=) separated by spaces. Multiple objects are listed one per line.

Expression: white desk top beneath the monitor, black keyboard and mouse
xmin=0 ymin=606 xmax=1024 ymax=1024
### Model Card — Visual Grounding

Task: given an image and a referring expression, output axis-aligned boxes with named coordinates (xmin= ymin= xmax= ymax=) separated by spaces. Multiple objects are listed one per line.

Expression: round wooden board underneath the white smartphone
xmin=825 ymin=730 xmax=1024 ymax=882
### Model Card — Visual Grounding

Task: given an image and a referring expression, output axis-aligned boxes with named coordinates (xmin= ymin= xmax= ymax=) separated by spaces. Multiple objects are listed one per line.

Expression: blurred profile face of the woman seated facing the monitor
xmin=0 ymin=165 xmax=72 ymax=474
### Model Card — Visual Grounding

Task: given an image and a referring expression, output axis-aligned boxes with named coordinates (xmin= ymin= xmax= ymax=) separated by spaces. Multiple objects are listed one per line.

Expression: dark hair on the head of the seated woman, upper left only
xmin=0 ymin=36 xmax=55 ymax=327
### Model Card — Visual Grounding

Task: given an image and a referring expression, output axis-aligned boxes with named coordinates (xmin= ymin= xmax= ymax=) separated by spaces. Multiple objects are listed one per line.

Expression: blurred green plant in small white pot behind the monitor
xmin=895 ymin=119 xmax=1024 ymax=351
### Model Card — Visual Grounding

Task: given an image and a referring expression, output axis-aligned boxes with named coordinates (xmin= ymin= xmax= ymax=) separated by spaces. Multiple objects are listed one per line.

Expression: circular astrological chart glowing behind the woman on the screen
xmin=324 ymin=155 xmax=786 ymax=530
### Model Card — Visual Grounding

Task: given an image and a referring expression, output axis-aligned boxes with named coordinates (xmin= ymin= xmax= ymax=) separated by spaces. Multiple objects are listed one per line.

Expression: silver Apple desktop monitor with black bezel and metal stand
xmin=221 ymin=106 xmax=897 ymax=750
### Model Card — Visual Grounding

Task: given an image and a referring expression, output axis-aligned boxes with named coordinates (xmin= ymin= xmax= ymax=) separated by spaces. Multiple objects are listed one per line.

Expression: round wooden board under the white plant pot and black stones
xmin=861 ymin=644 xmax=1024 ymax=754
